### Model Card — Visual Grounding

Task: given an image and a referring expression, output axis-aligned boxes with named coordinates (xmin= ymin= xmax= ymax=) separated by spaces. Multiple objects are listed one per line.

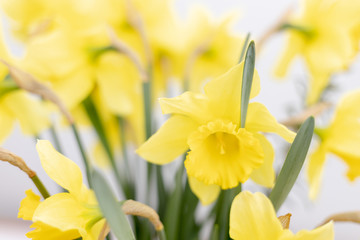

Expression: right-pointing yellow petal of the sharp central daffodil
xmin=245 ymin=102 xmax=295 ymax=142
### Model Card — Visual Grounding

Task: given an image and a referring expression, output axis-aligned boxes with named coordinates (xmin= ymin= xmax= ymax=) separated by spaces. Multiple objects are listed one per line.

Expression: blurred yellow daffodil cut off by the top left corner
xmin=0 ymin=0 xmax=114 ymax=42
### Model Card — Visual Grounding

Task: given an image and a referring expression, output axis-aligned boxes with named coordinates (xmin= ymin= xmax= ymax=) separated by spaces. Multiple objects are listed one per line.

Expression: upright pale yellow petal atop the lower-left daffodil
xmin=36 ymin=140 xmax=83 ymax=196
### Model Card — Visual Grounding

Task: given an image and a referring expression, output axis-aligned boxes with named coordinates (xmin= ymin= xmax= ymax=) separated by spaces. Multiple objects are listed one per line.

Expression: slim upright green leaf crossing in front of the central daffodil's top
xmin=240 ymin=41 xmax=255 ymax=128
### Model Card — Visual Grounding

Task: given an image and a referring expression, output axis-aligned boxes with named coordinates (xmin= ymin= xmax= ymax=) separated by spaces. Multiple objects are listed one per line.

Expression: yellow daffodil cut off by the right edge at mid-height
xmin=307 ymin=90 xmax=360 ymax=199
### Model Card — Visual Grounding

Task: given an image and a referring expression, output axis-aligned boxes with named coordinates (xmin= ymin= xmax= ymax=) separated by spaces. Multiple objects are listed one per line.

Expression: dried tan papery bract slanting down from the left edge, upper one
xmin=0 ymin=59 xmax=74 ymax=124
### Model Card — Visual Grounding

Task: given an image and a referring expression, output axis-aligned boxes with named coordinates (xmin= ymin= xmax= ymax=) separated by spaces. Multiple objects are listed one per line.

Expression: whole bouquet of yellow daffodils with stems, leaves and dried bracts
xmin=0 ymin=0 xmax=360 ymax=240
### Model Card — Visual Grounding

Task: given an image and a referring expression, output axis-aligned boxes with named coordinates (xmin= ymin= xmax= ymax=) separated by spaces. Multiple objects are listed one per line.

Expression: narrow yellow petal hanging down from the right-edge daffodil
xmin=307 ymin=146 xmax=326 ymax=199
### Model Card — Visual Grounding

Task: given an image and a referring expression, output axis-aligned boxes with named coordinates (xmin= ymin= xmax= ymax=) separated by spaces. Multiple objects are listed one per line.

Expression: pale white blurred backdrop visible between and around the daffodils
xmin=0 ymin=0 xmax=360 ymax=240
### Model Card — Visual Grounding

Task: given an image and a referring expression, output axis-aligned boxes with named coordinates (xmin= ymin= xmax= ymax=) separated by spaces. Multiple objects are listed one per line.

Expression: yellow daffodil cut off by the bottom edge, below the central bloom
xmin=230 ymin=191 xmax=334 ymax=240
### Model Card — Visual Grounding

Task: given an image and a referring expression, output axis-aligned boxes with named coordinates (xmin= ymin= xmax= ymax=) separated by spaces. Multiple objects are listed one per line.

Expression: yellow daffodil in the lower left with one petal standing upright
xmin=18 ymin=140 xmax=105 ymax=240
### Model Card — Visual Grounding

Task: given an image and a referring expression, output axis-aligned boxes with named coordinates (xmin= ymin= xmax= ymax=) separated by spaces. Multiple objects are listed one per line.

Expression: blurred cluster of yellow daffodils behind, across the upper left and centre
xmin=0 ymin=0 xmax=243 ymax=147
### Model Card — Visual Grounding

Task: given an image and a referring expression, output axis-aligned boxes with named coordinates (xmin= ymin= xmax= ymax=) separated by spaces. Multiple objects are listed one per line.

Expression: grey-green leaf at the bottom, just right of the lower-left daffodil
xmin=91 ymin=170 xmax=135 ymax=240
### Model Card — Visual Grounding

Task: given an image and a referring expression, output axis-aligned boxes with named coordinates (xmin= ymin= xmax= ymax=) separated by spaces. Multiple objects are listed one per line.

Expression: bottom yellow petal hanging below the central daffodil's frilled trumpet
xmin=188 ymin=177 xmax=221 ymax=206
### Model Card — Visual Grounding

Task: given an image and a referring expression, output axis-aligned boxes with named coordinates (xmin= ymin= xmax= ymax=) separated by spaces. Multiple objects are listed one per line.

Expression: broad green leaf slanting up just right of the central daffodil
xmin=269 ymin=117 xmax=315 ymax=211
